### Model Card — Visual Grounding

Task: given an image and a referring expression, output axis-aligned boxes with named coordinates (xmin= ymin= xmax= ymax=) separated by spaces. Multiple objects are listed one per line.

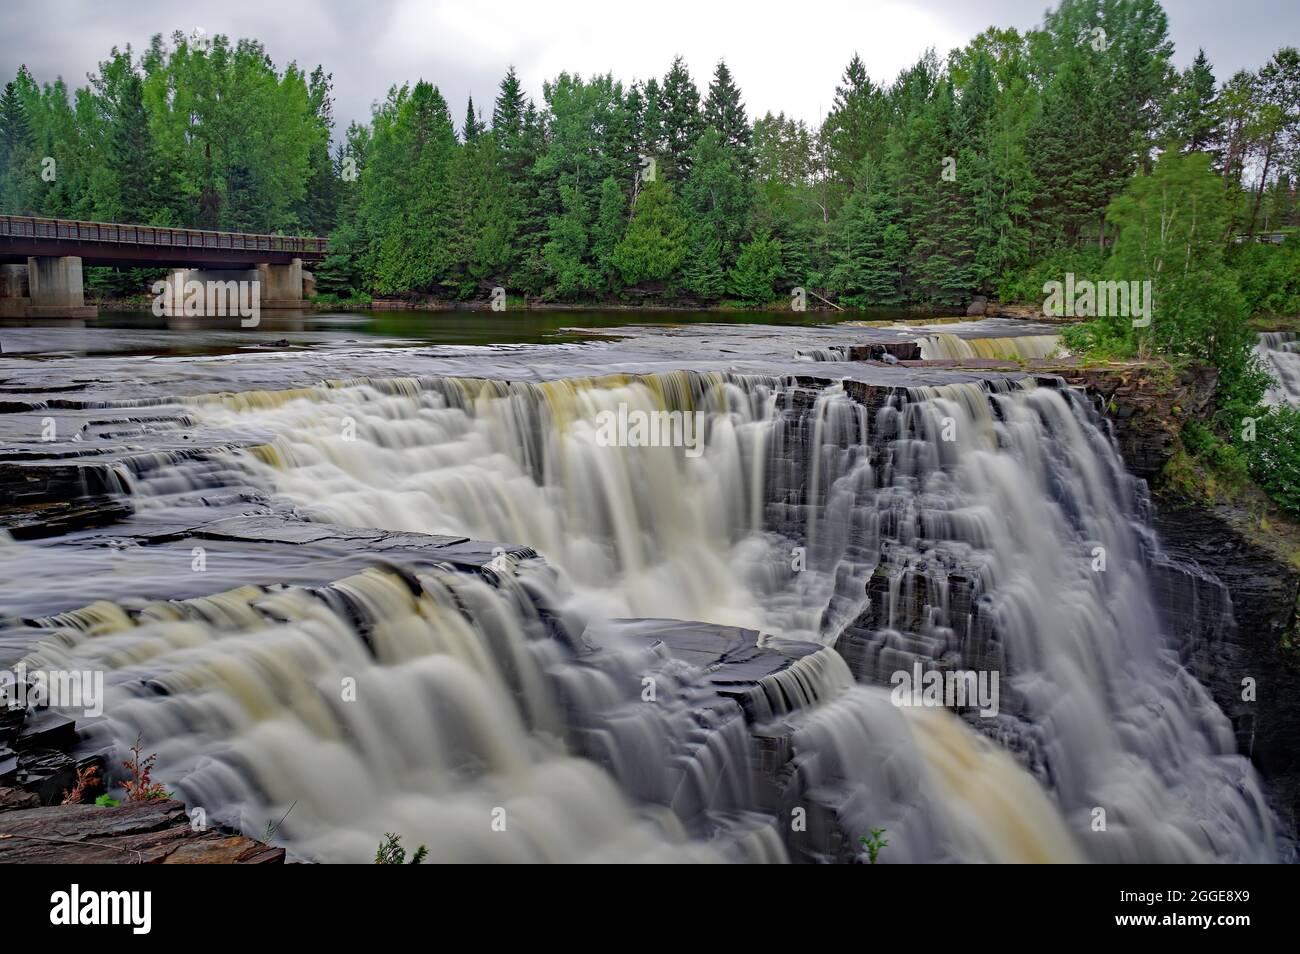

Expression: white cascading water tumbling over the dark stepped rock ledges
xmin=7 ymin=373 xmax=1274 ymax=862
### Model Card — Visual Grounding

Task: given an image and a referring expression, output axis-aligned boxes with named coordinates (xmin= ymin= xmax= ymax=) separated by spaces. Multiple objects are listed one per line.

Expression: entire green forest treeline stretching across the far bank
xmin=0 ymin=0 xmax=1300 ymax=305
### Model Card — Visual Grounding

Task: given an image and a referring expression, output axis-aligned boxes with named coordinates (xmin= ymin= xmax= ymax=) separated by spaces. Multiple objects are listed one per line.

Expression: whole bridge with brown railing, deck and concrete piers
xmin=0 ymin=216 xmax=329 ymax=318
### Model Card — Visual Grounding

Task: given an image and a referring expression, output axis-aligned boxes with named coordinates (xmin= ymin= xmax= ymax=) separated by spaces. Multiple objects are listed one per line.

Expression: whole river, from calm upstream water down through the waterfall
xmin=0 ymin=312 xmax=1279 ymax=862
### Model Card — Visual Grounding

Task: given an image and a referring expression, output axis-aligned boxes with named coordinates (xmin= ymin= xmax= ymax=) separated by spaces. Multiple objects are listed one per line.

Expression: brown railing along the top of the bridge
xmin=0 ymin=216 xmax=329 ymax=256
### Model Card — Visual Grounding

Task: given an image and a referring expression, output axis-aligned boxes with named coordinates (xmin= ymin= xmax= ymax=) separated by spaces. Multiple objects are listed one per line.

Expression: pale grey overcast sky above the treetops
xmin=0 ymin=0 xmax=1300 ymax=134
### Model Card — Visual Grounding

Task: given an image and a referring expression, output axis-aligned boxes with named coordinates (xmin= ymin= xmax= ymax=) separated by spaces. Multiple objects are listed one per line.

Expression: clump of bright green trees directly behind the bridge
xmin=0 ymin=34 xmax=345 ymax=234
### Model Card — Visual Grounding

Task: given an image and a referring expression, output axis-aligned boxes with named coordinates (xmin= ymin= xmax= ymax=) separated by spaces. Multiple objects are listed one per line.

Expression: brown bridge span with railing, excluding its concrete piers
xmin=0 ymin=216 xmax=329 ymax=268
